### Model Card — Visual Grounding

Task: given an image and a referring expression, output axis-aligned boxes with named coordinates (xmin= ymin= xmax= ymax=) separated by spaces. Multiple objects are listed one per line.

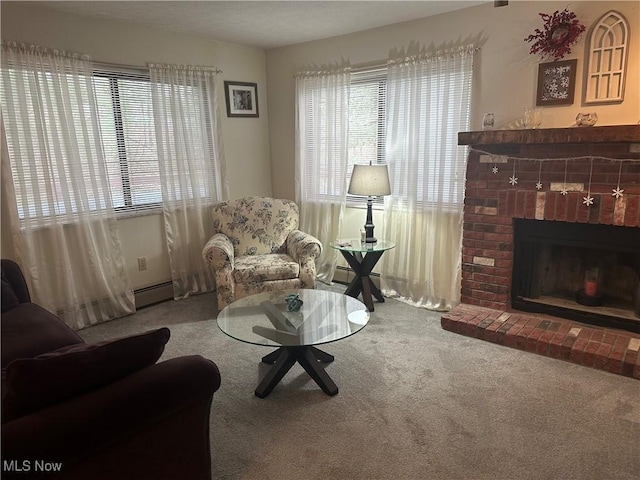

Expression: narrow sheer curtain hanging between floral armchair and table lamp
xmin=295 ymin=65 xmax=351 ymax=283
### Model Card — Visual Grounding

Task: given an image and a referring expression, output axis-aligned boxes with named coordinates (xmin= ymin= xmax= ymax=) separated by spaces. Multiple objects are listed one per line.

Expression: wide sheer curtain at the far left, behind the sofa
xmin=2 ymin=42 xmax=135 ymax=329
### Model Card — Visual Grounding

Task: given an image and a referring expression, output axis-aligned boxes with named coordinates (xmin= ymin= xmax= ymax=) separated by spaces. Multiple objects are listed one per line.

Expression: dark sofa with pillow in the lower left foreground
xmin=0 ymin=259 xmax=220 ymax=480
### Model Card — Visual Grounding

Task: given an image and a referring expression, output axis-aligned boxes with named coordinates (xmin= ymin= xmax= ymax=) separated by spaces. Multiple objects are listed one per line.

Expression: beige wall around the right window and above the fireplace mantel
xmin=267 ymin=0 xmax=640 ymax=203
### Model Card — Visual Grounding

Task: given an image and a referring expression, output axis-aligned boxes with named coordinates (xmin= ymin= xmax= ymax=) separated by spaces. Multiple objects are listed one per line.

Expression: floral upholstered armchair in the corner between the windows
xmin=202 ymin=197 xmax=322 ymax=310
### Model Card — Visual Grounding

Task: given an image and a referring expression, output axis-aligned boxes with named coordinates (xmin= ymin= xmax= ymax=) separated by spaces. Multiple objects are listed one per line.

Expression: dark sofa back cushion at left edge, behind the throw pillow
xmin=0 ymin=303 xmax=84 ymax=368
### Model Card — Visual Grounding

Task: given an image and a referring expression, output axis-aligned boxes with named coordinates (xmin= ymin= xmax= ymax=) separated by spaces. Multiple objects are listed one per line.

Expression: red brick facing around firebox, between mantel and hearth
xmin=461 ymin=150 xmax=640 ymax=310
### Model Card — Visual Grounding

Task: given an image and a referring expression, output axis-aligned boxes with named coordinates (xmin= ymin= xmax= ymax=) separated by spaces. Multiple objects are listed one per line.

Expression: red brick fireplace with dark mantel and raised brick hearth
xmin=442 ymin=125 xmax=640 ymax=378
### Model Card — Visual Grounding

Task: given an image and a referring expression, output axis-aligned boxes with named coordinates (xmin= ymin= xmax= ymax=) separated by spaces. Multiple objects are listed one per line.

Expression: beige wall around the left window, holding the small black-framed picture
xmin=1 ymin=2 xmax=272 ymax=288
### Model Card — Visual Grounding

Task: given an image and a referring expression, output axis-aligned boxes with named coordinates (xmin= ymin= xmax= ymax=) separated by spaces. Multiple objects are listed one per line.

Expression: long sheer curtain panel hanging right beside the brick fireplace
xmin=381 ymin=45 xmax=475 ymax=310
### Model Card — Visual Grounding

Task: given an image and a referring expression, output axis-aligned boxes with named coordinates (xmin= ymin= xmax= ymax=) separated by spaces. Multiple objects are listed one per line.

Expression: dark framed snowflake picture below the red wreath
xmin=536 ymin=60 xmax=578 ymax=107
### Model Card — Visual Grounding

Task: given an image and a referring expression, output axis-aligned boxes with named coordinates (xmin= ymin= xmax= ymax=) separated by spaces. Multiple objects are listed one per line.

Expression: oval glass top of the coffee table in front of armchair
xmin=218 ymin=289 xmax=369 ymax=346
